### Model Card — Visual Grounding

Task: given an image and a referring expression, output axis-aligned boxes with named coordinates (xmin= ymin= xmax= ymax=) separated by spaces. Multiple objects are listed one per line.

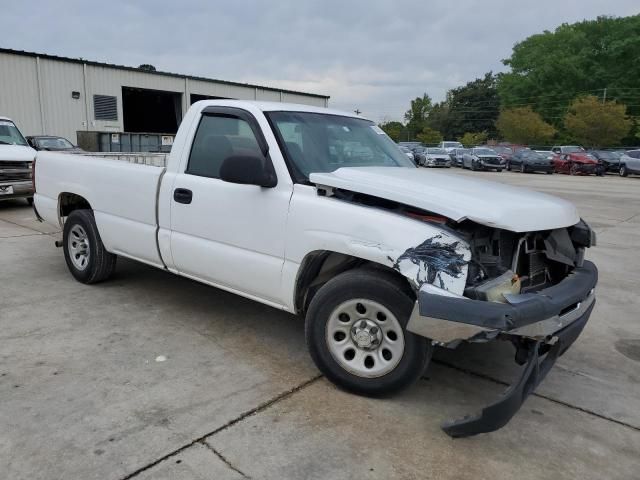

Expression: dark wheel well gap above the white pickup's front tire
xmin=295 ymin=250 xmax=414 ymax=315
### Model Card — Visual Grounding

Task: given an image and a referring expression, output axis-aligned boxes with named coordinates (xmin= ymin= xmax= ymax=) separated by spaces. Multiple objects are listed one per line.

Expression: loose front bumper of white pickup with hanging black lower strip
xmin=407 ymin=261 xmax=598 ymax=437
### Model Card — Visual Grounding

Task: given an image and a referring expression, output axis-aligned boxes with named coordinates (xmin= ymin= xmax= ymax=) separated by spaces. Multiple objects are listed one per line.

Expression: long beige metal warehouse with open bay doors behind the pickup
xmin=0 ymin=48 xmax=329 ymax=152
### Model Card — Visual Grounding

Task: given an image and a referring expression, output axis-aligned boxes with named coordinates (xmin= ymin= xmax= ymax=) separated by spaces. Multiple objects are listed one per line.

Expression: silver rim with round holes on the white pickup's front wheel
xmin=326 ymin=298 xmax=405 ymax=378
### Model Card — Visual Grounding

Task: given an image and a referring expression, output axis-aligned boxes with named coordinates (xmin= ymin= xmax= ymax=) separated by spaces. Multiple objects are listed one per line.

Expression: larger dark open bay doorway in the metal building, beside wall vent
xmin=122 ymin=87 xmax=182 ymax=133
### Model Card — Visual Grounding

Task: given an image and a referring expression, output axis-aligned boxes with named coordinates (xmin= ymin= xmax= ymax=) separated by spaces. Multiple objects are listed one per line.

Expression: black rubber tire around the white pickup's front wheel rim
xmin=305 ymin=269 xmax=433 ymax=396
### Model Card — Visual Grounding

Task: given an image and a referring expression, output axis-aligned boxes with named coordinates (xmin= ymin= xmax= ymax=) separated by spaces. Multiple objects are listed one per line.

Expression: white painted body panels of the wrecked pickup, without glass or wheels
xmin=35 ymin=101 xmax=579 ymax=312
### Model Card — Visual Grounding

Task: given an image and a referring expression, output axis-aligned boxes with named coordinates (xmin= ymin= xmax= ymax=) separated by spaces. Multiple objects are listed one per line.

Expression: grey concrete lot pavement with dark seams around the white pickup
xmin=0 ymin=169 xmax=640 ymax=480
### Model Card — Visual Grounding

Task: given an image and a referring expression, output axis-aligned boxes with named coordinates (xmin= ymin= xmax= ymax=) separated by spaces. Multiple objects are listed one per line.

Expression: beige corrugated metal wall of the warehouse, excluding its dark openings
xmin=0 ymin=52 xmax=327 ymax=143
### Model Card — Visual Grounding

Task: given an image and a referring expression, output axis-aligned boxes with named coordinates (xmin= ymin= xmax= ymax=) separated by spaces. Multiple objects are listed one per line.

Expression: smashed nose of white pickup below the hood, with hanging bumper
xmin=402 ymin=220 xmax=598 ymax=437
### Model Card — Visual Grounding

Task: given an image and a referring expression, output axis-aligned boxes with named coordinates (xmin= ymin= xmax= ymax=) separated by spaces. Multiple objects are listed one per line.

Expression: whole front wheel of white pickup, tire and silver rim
xmin=305 ymin=270 xmax=432 ymax=396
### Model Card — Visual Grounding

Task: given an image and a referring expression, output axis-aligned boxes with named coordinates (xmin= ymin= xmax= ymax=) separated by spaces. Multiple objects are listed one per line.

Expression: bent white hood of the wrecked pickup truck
xmin=310 ymin=167 xmax=580 ymax=232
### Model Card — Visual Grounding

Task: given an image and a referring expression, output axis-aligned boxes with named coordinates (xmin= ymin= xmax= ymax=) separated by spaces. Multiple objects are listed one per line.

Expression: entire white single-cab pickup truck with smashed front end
xmin=34 ymin=100 xmax=597 ymax=437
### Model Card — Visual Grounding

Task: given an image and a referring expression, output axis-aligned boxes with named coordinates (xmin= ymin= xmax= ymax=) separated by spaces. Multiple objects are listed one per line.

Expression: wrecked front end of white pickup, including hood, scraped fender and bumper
xmin=311 ymin=168 xmax=598 ymax=437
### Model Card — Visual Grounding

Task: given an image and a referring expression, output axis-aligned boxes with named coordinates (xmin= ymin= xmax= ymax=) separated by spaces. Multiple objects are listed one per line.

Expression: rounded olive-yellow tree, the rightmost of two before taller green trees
xmin=564 ymin=95 xmax=633 ymax=147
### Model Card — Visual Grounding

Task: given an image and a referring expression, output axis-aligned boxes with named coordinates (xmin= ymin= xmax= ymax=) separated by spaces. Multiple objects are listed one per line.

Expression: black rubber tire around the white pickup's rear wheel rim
xmin=62 ymin=210 xmax=118 ymax=284
